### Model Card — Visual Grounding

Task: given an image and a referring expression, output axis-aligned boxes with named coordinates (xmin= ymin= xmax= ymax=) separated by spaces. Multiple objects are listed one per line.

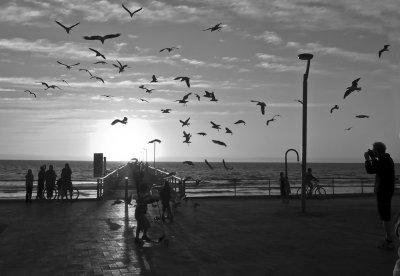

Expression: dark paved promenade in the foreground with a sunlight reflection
xmin=0 ymin=197 xmax=400 ymax=276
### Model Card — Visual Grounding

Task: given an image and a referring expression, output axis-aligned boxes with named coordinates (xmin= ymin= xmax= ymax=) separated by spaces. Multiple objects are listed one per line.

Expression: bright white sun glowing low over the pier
xmin=90 ymin=119 xmax=157 ymax=161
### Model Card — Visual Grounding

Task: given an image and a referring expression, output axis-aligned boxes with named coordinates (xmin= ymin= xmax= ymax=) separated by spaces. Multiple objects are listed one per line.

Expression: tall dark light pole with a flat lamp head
xmin=298 ymin=53 xmax=314 ymax=213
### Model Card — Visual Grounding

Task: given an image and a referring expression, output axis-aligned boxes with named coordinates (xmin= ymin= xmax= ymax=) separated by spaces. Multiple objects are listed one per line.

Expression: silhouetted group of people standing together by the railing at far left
xmin=25 ymin=163 xmax=72 ymax=202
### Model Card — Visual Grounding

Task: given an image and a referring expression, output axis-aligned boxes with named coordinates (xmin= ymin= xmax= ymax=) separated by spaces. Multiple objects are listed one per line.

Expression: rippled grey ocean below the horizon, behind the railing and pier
xmin=0 ymin=160 xmax=399 ymax=198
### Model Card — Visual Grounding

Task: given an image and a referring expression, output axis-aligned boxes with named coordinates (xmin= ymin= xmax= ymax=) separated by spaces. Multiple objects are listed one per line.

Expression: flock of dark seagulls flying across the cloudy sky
xmin=18 ymin=4 xmax=390 ymax=169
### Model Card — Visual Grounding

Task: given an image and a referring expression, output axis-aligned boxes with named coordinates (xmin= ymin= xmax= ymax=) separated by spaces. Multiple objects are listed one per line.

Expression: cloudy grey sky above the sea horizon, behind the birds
xmin=0 ymin=0 xmax=400 ymax=162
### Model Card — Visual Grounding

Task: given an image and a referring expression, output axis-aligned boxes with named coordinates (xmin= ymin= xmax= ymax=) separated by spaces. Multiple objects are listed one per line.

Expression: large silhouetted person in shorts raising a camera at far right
xmin=364 ymin=142 xmax=395 ymax=249
